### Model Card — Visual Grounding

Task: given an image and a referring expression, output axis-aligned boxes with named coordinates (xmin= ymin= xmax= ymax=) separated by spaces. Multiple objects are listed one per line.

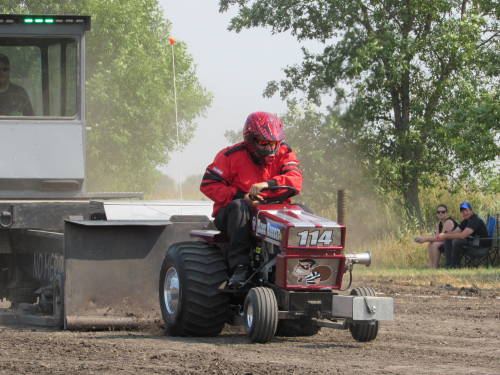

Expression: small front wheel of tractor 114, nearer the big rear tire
xmin=243 ymin=287 xmax=278 ymax=343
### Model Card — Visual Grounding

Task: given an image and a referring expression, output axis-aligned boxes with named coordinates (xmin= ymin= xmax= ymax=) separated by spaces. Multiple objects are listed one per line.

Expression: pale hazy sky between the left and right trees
xmin=159 ymin=0 xmax=314 ymax=181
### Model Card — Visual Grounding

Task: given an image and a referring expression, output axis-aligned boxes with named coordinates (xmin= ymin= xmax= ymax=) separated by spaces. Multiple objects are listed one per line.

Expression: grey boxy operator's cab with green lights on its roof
xmin=0 ymin=15 xmax=90 ymax=199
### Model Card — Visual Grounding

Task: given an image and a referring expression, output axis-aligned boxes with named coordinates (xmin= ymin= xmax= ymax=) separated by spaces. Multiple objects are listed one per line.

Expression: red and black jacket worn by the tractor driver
xmin=200 ymin=142 xmax=302 ymax=217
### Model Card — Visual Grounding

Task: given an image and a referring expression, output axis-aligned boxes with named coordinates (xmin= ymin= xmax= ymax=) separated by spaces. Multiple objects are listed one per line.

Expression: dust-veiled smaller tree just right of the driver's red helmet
xmin=281 ymin=102 xmax=374 ymax=212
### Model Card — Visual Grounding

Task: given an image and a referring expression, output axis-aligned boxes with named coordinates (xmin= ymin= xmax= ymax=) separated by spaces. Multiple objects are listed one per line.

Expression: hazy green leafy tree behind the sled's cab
xmin=0 ymin=0 xmax=211 ymax=192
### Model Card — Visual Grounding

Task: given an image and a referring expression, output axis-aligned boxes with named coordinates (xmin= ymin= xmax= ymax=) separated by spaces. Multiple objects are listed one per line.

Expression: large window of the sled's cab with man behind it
xmin=0 ymin=37 xmax=79 ymax=118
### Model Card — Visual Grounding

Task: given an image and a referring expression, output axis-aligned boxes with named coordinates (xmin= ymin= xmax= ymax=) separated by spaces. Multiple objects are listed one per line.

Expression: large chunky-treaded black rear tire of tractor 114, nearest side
xmin=159 ymin=241 xmax=228 ymax=336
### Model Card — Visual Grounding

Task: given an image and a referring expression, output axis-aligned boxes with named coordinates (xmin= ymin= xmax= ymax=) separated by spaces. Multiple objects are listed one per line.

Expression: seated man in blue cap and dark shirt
xmin=438 ymin=202 xmax=491 ymax=268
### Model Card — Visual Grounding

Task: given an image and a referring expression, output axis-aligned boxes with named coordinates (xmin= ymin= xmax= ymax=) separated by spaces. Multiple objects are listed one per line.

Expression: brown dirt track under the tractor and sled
xmin=0 ymin=284 xmax=500 ymax=375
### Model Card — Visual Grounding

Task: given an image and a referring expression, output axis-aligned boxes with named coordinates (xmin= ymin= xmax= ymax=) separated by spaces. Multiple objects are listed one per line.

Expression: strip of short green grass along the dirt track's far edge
xmin=353 ymin=266 xmax=500 ymax=291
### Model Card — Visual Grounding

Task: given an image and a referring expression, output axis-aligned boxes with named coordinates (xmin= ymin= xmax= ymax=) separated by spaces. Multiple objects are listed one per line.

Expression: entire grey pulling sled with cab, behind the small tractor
xmin=0 ymin=14 xmax=211 ymax=329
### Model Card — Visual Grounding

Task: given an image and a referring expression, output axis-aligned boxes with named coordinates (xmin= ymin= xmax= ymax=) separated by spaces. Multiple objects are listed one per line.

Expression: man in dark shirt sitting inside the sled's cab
xmin=0 ymin=54 xmax=34 ymax=116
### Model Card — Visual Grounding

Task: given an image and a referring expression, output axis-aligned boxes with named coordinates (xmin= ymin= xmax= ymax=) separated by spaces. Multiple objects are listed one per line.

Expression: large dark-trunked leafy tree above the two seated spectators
xmin=220 ymin=0 xmax=500 ymax=220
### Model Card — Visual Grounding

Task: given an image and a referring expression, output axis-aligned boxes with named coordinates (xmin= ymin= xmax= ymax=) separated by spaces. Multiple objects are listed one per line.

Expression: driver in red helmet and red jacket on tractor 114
xmin=200 ymin=112 xmax=302 ymax=287
